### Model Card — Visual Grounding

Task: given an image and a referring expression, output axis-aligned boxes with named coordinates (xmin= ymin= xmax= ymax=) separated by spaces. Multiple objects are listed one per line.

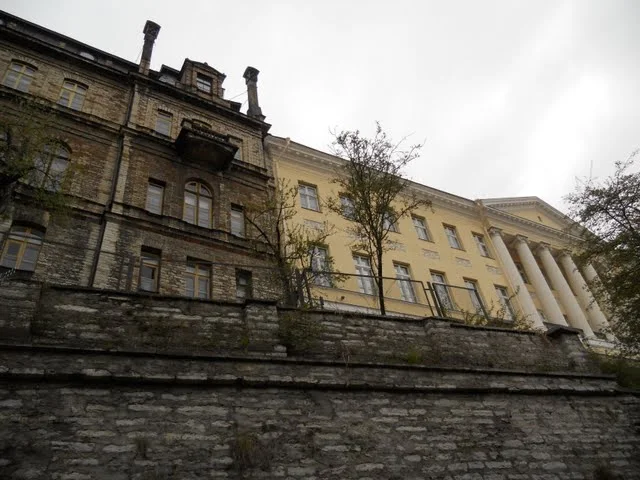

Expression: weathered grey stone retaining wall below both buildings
xmin=0 ymin=281 xmax=640 ymax=480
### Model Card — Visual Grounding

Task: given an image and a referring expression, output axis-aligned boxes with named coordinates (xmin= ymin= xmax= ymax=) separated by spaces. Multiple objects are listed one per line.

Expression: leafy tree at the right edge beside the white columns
xmin=566 ymin=151 xmax=640 ymax=354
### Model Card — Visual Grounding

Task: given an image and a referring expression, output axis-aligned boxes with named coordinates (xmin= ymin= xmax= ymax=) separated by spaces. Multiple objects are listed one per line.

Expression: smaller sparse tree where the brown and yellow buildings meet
xmin=245 ymin=180 xmax=334 ymax=305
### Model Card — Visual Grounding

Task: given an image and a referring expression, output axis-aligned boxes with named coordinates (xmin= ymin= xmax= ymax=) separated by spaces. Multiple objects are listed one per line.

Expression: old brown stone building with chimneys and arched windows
xmin=0 ymin=12 xmax=280 ymax=298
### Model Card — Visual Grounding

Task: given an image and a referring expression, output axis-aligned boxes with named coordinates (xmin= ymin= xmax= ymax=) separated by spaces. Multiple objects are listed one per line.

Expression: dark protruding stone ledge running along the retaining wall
xmin=0 ymin=347 xmax=628 ymax=395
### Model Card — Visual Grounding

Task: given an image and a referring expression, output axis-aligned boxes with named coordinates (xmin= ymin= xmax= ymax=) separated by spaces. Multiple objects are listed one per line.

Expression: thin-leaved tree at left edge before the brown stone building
xmin=0 ymin=99 xmax=69 ymax=217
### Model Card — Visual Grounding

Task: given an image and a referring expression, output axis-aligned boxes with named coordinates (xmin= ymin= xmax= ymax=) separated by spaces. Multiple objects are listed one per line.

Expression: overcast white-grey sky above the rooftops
xmin=0 ymin=0 xmax=640 ymax=208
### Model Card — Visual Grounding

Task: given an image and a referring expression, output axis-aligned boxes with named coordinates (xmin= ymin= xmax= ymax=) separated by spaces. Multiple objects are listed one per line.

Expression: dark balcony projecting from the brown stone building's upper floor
xmin=176 ymin=119 xmax=238 ymax=171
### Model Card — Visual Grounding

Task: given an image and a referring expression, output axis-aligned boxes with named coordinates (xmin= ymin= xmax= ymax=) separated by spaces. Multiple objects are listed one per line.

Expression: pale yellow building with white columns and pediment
xmin=266 ymin=136 xmax=608 ymax=344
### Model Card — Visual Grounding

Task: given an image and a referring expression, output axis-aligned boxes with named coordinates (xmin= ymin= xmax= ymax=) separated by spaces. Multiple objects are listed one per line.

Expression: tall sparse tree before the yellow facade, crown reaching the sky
xmin=327 ymin=122 xmax=431 ymax=315
